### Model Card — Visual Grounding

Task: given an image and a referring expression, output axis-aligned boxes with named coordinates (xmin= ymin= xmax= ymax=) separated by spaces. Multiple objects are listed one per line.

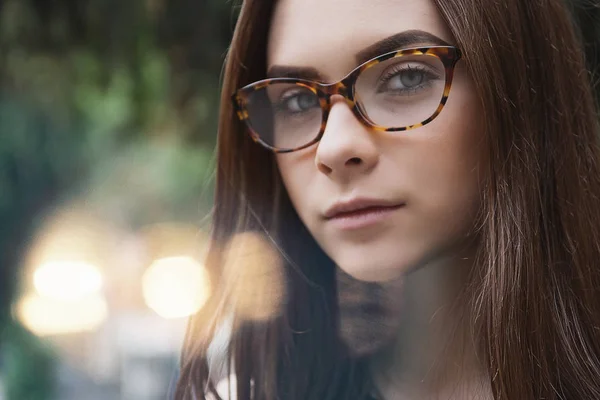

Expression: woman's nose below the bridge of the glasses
xmin=315 ymin=96 xmax=379 ymax=181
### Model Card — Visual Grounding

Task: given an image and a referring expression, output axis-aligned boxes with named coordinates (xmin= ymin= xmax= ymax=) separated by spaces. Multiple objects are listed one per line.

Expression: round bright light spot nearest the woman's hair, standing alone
xmin=142 ymin=257 xmax=210 ymax=318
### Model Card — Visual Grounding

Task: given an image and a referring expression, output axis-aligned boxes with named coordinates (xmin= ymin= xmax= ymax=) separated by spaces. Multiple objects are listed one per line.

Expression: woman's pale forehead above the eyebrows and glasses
xmin=267 ymin=0 xmax=453 ymax=79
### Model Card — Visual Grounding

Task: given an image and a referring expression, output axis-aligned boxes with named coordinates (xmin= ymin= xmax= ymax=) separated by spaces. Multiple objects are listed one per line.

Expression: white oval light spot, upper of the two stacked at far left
xmin=33 ymin=261 xmax=102 ymax=300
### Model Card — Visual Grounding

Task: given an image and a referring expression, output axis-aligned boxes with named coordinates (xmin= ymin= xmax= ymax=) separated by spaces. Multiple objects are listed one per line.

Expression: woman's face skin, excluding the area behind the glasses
xmin=267 ymin=0 xmax=484 ymax=281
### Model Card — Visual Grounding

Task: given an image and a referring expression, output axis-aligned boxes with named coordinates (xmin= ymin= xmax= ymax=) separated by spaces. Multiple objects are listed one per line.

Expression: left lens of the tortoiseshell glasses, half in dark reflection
xmin=246 ymin=83 xmax=323 ymax=149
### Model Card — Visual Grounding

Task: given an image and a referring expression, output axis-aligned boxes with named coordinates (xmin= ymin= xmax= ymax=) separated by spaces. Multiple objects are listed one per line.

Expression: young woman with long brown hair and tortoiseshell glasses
xmin=177 ymin=0 xmax=600 ymax=400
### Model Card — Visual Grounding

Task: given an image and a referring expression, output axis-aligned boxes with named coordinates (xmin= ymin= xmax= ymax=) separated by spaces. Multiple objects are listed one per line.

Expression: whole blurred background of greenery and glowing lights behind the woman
xmin=0 ymin=0 xmax=600 ymax=400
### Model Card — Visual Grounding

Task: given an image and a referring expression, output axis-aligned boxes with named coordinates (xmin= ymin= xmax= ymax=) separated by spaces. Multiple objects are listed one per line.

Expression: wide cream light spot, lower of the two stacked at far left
xmin=17 ymin=295 xmax=108 ymax=336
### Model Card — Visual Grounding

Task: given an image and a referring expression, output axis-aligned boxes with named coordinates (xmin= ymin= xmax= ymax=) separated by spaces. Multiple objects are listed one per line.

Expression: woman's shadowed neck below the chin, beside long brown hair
xmin=371 ymin=245 xmax=489 ymax=400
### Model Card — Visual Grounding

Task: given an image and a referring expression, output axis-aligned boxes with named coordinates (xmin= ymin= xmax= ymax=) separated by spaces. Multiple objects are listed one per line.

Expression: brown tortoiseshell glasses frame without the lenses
xmin=232 ymin=46 xmax=462 ymax=153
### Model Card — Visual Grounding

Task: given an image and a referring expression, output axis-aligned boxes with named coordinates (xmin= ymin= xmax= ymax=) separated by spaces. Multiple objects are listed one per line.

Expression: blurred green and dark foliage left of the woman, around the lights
xmin=0 ymin=0 xmax=235 ymax=400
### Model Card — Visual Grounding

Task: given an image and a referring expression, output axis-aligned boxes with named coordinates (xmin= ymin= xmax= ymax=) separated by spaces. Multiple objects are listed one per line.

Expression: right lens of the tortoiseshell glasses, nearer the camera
xmin=354 ymin=55 xmax=446 ymax=128
